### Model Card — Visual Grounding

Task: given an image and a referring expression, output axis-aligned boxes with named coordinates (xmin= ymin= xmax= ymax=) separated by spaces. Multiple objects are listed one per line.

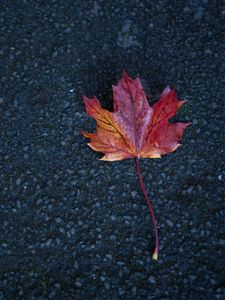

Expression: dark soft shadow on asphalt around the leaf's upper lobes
xmin=78 ymin=54 xmax=166 ymax=111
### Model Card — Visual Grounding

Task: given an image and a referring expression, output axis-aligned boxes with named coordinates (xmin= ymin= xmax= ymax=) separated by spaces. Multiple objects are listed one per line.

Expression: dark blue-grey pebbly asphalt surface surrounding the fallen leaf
xmin=0 ymin=0 xmax=225 ymax=300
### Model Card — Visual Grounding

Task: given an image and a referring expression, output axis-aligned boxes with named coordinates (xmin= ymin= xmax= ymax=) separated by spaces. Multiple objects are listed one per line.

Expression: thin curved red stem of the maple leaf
xmin=136 ymin=158 xmax=159 ymax=260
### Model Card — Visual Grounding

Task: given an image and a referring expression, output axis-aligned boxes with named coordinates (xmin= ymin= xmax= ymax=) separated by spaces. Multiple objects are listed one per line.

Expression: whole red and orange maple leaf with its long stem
xmin=81 ymin=71 xmax=191 ymax=259
